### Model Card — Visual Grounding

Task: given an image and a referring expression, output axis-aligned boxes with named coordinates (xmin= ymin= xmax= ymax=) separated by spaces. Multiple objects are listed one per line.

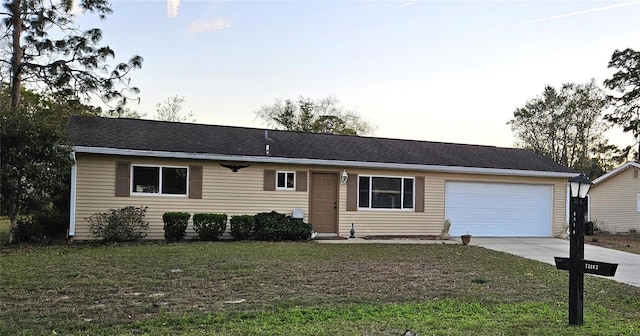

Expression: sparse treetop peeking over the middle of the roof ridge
xmin=255 ymin=96 xmax=375 ymax=135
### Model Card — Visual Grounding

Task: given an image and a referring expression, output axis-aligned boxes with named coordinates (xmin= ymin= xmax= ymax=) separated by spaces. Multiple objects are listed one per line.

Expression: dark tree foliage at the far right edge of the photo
xmin=604 ymin=48 xmax=640 ymax=160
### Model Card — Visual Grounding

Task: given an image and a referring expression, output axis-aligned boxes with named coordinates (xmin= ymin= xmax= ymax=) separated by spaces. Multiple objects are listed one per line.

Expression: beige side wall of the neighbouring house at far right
xmin=589 ymin=167 xmax=640 ymax=233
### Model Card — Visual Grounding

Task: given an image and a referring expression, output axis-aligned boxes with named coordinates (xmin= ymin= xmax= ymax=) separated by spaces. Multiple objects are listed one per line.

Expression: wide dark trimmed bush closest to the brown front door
xmin=254 ymin=211 xmax=311 ymax=241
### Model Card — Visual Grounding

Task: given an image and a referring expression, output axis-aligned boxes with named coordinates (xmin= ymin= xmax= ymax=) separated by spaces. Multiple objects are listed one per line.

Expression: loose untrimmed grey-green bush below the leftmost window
xmin=87 ymin=206 xmax=149 ymax=242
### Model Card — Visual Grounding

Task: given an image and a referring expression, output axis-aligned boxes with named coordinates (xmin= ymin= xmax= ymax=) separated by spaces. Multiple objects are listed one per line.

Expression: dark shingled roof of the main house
xmin=69 ymin=116 xmax=573 ymax=173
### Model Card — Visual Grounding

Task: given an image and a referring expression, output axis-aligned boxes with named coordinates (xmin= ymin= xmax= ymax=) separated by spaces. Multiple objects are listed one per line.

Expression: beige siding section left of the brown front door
xmin=74 ymin=155 xmax=309 ymax=240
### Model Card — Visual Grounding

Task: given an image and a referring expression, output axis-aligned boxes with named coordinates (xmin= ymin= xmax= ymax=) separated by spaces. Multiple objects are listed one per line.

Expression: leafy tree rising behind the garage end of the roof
xmin=508 ymin=80 xmax=620 ymax=178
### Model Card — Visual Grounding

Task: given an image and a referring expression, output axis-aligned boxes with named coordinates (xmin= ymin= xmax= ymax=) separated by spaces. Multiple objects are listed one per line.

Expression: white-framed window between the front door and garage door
xmin=358 ymin=176 xmax=414 ymax=209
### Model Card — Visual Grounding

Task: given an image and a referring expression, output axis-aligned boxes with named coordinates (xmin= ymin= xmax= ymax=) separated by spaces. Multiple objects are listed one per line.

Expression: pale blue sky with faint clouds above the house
xmin=79 ymin=0 xmax=640 ymax=147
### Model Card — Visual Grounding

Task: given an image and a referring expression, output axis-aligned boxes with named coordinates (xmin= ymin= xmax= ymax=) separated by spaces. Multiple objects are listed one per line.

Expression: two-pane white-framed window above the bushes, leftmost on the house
xmin=131 ymin=166 xmax=187 ymax=195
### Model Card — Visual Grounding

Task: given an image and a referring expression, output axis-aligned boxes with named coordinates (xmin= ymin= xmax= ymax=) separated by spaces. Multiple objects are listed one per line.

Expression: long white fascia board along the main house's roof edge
xmin=73 ymin=146 xmax=577 ymax=178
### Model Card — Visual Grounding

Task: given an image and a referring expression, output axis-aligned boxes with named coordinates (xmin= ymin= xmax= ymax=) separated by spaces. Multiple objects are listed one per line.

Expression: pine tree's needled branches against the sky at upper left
xmin=0 ymin=0 xmax=142 ymax=110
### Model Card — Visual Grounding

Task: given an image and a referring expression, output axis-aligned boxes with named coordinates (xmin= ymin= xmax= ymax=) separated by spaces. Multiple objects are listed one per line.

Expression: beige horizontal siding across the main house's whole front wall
xmin=75 ymin=154 xmax=566 ymax=240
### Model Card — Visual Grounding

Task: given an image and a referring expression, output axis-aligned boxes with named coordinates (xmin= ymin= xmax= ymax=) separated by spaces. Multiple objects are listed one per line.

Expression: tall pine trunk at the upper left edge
xmin=11 ymin=0 xmax=22 ymax=112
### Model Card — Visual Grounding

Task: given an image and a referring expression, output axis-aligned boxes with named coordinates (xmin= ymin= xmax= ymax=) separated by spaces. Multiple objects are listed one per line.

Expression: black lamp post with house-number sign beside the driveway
xmin=555 ymin=174 xmax=618 ymax=325
